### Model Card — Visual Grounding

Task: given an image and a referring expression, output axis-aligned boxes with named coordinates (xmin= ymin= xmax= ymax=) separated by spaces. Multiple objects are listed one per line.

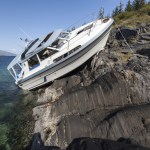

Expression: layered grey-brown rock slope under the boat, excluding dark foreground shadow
xmin=30 ymin=25 xmax=150 ymax=148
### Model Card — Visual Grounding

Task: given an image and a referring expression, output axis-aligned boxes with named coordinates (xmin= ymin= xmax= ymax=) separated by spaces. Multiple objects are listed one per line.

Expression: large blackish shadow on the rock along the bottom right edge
xmin=66 ymin=138 xmax=149 ymax=150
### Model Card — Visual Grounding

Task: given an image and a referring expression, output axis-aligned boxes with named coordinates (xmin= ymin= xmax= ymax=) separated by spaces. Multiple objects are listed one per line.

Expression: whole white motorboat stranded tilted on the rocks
xmin=7 ymin=18 xmax=113 ymax=90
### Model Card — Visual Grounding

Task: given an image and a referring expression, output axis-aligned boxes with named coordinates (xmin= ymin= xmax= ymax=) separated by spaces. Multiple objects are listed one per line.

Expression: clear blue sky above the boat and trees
xmin=0 ymin=0 xmax=128 ymax=54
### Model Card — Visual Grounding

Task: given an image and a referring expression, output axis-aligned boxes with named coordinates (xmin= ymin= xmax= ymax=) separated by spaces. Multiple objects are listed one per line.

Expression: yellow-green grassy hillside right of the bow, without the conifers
xmin=114 ymin=5 xmax=150 ymax=27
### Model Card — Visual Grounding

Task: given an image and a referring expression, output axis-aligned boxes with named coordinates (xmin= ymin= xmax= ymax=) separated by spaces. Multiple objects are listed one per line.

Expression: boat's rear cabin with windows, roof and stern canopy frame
xmin=7 ymin=30 xmax=70 ymax=82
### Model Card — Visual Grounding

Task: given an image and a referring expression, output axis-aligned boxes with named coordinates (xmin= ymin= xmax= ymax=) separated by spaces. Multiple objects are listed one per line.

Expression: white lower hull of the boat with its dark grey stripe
xmin=18 ymin=27 xmax=110 ymax=90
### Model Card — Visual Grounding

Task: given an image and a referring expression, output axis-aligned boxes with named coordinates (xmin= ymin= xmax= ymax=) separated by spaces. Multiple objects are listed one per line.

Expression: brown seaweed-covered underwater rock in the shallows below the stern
xmin=6 ymin=92 xmax=36 ymax=150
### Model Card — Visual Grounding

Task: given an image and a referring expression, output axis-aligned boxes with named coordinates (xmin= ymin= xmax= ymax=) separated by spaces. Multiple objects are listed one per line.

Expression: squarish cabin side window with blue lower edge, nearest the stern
xmin=28 ymin=55 xmax=40 ymax=70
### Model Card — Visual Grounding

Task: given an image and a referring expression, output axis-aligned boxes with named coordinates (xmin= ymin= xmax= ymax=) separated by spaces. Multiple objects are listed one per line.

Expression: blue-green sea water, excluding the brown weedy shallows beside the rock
xmin=0 ymin=56 xmax=19 ymax=150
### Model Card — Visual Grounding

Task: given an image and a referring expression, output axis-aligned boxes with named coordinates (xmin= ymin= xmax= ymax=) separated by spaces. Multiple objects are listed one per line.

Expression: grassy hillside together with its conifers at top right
xmin=112 ymin=0 xmax=150 ymax=27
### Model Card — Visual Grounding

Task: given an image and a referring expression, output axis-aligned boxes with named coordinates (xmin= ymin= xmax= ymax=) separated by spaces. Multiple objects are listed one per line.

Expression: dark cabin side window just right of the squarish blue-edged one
xmin=38 ymin=48 xmax=57 ymax=61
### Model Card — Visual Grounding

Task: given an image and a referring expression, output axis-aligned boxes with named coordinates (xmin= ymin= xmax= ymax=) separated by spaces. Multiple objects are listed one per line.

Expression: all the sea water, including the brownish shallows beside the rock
xmin=0 ymin=56 xmax=36 ymax=150
